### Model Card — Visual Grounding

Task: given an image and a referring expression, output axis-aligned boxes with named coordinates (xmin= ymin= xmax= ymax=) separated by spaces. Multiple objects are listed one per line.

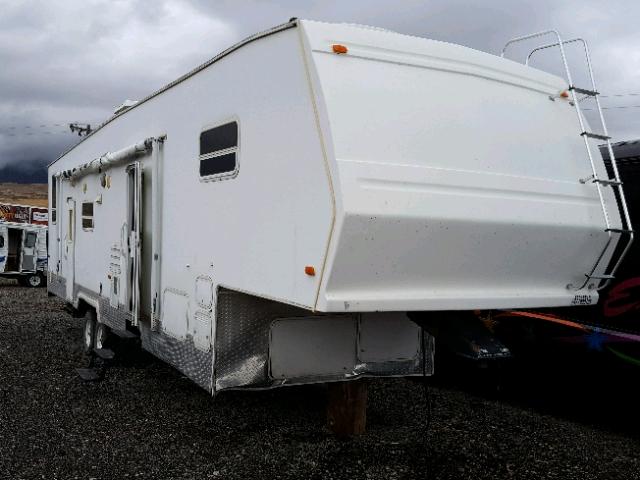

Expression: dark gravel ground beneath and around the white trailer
xmin=0 ymin=280 xmax=640 ymax=480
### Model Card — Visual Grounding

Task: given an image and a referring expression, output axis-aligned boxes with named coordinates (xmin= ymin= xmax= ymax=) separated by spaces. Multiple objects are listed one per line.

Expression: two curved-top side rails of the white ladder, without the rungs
xmin=500 ymin=30 xmax=634 ymax=290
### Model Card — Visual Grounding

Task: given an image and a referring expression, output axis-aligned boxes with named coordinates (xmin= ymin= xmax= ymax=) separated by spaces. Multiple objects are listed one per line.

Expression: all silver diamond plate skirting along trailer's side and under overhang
xmin=48 ymin=273 xmax=434 ymax=394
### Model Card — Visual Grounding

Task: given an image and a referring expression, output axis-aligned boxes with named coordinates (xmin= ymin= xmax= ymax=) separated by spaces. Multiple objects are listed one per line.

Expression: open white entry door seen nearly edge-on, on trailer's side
xmin=125 ymin=162 xmax=142 ymax=325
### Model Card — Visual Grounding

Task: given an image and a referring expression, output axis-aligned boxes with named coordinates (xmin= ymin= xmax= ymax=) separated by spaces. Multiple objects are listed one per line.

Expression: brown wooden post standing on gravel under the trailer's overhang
xmin=327 ymin=380 xmax=367 ymax=437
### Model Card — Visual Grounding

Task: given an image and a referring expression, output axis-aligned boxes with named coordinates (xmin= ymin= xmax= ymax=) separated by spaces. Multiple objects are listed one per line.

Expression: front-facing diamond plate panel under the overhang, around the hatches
xmin=214 ymin=288 xmax=435 ymax=391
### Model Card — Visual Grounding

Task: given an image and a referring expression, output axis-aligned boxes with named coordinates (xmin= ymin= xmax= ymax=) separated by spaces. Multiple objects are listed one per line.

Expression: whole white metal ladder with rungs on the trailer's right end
xmin=501 ymin=30 xmax=634 ymax=290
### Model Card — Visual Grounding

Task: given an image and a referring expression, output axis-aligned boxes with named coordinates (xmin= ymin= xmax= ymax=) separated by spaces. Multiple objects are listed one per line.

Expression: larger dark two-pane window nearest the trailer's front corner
xmin=200 ymin=122 xmax=238 ymax=177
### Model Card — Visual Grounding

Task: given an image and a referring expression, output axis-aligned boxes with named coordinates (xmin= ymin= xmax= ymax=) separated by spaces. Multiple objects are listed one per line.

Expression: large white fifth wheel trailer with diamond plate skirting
xmin=48 ymin=19 xmax=631 ymax=393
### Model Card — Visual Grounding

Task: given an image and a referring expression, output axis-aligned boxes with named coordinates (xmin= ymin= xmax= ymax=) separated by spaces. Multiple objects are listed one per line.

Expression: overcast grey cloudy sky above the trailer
xmin=0 ymin=0 xmax=640 ymax=181
